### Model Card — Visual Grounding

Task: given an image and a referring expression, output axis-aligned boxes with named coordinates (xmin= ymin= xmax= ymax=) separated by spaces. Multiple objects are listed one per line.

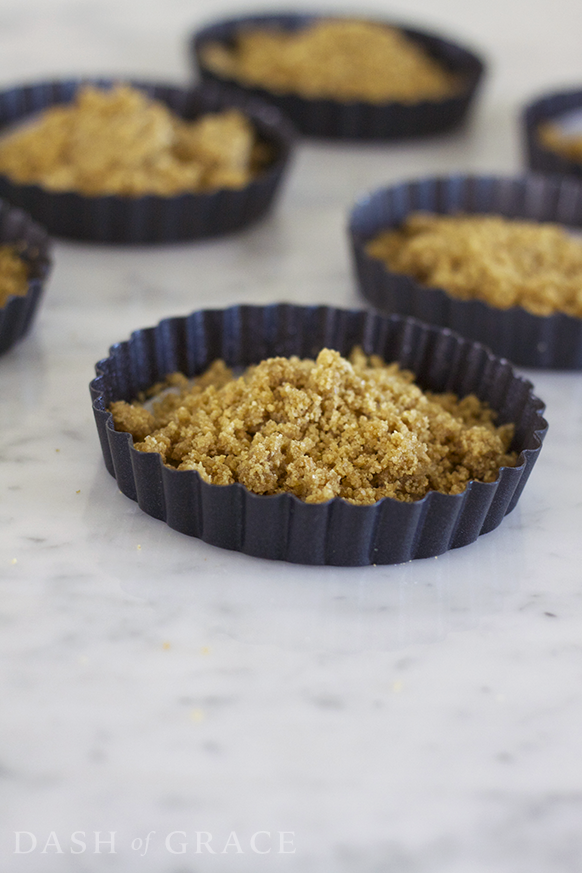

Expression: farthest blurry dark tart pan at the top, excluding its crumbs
xmin=190 ymin=14 xmax=484 ymax=140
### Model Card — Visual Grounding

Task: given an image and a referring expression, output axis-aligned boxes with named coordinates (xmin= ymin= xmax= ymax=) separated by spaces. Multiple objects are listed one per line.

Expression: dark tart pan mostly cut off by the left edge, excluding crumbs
xmin=0 ymin=200 xmax=51 ymax=355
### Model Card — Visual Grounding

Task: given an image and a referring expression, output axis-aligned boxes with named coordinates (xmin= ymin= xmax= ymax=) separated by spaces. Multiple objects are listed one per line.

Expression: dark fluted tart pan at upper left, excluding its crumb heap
xmin=0 ymin=79 xmax=293 ymax=243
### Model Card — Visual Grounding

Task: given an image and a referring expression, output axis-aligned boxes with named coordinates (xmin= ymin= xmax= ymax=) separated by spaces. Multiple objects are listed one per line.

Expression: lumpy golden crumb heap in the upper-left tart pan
xmin=0 ymin=84 xmax=267 ymax=196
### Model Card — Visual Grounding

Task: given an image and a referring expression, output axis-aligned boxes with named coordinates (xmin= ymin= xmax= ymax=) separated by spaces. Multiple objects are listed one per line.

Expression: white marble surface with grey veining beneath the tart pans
xmin=0 ymin=0 xmax=582 ymax=873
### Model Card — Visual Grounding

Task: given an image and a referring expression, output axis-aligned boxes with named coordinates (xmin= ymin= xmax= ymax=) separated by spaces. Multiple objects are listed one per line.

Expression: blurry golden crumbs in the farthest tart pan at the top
xmin=202 ymin=19 xmax=460 ymax=103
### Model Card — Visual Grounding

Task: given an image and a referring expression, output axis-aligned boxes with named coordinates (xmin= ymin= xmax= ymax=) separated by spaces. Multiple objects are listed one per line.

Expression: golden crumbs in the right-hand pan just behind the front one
xmin=366 ymin=212 xmax=582 ymax=318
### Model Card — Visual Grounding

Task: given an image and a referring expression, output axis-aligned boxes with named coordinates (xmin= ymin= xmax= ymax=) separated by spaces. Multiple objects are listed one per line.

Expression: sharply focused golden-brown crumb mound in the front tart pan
xmin=110 ymin=348 xmax=516 ymax=504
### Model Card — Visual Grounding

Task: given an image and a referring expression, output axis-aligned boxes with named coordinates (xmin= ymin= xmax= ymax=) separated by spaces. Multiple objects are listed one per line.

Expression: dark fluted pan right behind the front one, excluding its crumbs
xmin=349 ymin=174 xmax=582 ymax=370
